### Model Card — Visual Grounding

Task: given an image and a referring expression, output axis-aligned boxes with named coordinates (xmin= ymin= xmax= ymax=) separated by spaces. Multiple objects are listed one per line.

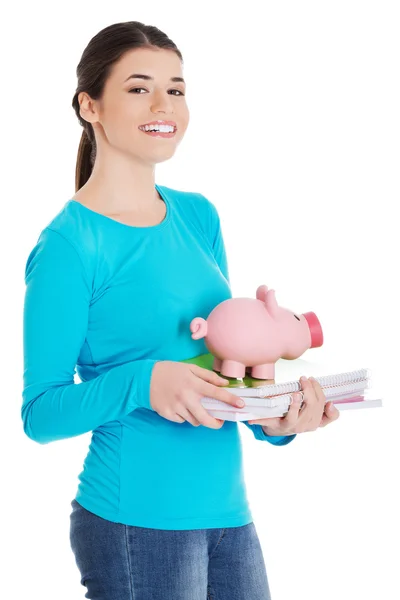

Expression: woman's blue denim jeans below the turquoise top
xmin=70 ymin=499 xmax=271 ymax=600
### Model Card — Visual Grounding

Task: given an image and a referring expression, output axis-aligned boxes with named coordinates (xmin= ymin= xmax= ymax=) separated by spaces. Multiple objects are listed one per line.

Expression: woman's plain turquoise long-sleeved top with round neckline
xmin=21 ymin=185 xmax=296 ymax=529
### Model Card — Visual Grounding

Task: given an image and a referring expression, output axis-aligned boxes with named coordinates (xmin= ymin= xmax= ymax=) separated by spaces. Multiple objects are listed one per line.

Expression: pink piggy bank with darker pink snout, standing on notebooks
xmin=190 ymin=285 xmax=323 ymax=379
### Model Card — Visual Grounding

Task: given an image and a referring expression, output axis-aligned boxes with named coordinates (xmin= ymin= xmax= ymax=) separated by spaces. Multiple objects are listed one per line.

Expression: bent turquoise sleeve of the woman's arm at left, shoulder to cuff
xmin=21 ymin=228 xmax=157 ymax=444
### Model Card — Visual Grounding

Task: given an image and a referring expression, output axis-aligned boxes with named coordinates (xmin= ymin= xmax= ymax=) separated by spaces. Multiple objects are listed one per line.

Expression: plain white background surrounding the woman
xmin=0 ymin=0 xmax=400 ymax=600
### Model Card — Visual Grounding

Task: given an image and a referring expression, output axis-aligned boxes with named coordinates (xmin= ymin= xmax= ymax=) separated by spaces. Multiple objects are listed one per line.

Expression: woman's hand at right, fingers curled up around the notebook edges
xmin=248 ymin=377 xmax=340 ymax=436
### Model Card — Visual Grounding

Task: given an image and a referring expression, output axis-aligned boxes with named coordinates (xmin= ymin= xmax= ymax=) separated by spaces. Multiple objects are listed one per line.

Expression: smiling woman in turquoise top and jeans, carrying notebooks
xmin=22 ymin=22 xmax=339 ymax=600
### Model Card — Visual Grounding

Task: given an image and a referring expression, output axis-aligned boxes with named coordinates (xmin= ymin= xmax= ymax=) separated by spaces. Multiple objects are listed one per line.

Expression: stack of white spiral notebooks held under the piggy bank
xmin=201 ymin=361 xmax=382 ymax=421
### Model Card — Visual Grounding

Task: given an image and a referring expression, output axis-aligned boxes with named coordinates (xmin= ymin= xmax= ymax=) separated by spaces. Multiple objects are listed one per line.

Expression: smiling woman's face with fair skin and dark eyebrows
xmin=82 ymin=48 xmax=189 ymax=164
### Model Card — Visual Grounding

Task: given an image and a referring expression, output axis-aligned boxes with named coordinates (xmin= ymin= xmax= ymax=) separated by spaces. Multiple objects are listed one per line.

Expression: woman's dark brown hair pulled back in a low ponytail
xmin=72 ymin=21 xmax=183 ymax=192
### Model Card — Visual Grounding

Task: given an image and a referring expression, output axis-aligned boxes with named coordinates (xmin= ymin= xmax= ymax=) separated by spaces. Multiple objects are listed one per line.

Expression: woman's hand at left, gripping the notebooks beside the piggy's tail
xmin=150 ymin=360 xmax=243 ymax=429
